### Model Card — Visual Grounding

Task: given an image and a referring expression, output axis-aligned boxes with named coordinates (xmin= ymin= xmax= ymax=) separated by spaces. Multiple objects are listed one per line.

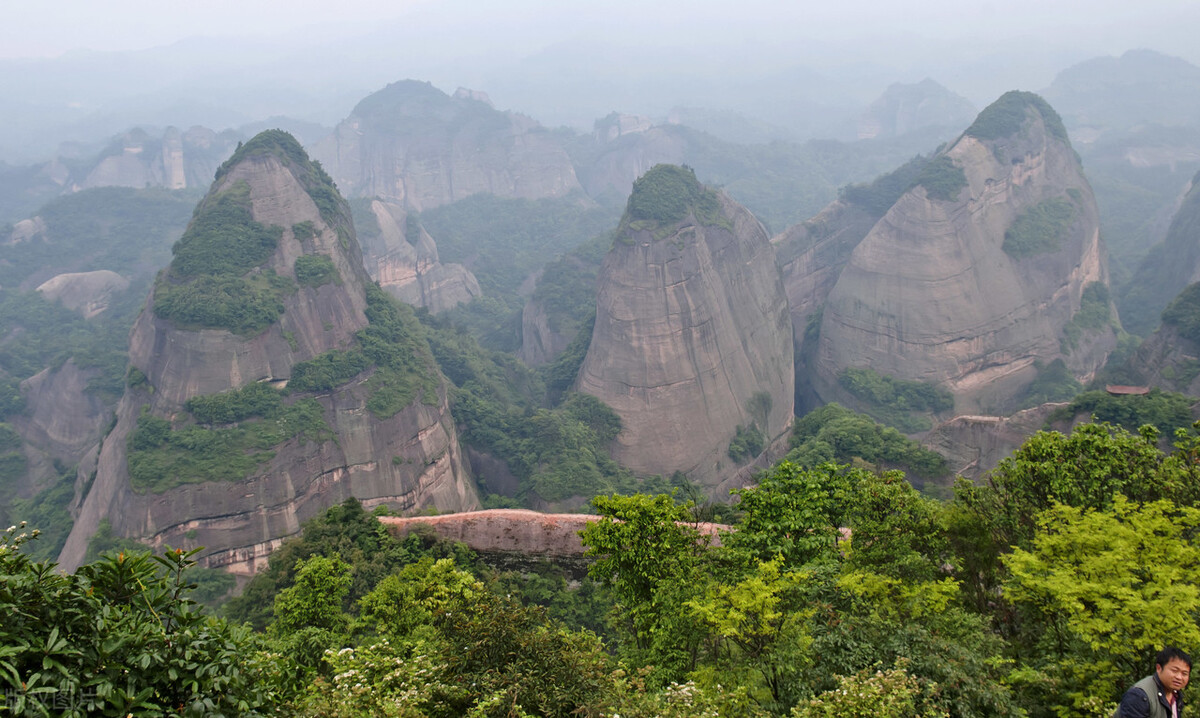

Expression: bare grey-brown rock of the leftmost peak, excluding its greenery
xmin=61 ymin=132 xmax=478 ymax=573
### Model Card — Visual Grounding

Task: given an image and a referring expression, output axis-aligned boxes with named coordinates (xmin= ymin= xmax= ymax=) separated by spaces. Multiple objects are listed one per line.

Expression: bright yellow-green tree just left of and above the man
xmin=1004 ymin=495 xmax=1200 ymax=716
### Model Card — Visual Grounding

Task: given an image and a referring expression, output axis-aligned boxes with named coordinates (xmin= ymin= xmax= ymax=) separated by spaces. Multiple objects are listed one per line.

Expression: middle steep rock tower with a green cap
xmin=576 ymin=166 xmax=794 ymax=487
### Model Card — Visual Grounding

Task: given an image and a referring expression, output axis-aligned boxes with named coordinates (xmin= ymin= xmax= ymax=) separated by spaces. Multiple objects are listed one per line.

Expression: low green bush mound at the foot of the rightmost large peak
xmin=787 ymin=403 xmax=949 ymax=479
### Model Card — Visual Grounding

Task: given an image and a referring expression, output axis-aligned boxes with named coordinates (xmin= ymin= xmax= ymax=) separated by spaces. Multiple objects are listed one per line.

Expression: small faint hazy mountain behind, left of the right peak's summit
xmin=858 ymin=77 xmax=976 ymax=139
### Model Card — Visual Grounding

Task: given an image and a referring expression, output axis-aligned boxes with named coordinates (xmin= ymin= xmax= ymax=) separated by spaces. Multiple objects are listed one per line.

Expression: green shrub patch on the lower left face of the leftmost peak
xmin=128 ymin=384 xmax=332 ymax=493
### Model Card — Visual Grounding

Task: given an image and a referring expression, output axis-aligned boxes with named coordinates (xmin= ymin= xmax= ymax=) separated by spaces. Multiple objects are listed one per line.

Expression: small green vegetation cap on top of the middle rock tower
xmin=625 ymin=164 xmax=728 ymax=226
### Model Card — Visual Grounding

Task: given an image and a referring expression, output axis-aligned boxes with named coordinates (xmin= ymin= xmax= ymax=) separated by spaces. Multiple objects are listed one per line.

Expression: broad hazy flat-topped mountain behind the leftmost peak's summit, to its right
xmin=313 ymin=80 xmax=580 ymax=210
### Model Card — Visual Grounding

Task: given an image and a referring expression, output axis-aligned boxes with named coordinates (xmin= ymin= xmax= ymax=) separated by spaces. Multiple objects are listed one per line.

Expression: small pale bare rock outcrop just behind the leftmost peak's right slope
xmin=361 ymin=199 xmax=481 ymax=313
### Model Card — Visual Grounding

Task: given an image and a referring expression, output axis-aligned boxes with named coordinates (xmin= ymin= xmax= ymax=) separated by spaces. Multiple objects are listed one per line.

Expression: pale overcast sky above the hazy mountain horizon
xmin=9 ymin=0 xmax=1200 ymax=61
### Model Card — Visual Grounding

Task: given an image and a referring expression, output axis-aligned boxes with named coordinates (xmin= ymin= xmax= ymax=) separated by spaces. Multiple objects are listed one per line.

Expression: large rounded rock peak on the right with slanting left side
xmin=814 ymin=92 xmax=1116 ymax=413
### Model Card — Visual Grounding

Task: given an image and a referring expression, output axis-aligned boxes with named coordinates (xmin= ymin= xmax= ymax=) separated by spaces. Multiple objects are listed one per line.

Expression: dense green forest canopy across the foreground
xmin=18 ymin=414 xmax=1200 ymax=718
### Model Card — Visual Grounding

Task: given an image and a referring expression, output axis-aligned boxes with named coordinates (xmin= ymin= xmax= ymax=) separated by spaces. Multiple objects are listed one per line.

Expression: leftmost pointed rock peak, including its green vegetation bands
xmin=61 ymin=131 xmax=478 ymax=572
